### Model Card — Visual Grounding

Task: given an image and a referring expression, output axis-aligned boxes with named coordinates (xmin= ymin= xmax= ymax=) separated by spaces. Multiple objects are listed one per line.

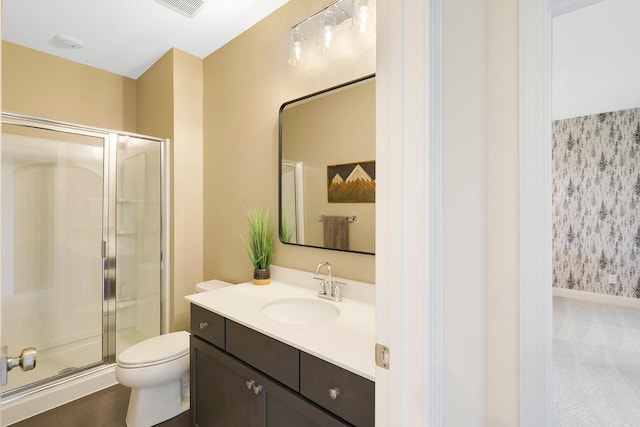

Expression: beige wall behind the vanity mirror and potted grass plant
xmin=204 ymin=0 xmax=375 ymax=288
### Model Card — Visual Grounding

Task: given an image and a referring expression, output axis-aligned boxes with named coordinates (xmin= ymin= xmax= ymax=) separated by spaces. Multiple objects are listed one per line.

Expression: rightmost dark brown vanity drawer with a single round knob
xmin=300 ymin=352 xmax=375 ymax=426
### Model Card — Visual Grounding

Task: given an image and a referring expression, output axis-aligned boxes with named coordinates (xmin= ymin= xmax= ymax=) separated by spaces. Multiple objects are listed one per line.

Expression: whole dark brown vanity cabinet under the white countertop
xmin=191 ymin=306 xmax=374 ymax=427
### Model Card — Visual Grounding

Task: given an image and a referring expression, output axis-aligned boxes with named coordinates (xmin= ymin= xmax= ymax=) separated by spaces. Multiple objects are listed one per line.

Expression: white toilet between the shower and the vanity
xmin=116 ymin=280 xmax=231 ymax=427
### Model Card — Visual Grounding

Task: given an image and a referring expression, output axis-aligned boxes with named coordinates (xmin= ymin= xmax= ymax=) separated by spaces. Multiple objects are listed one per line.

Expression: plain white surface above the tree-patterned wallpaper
xmin=552 ymin=0 xmax=640 ymax=120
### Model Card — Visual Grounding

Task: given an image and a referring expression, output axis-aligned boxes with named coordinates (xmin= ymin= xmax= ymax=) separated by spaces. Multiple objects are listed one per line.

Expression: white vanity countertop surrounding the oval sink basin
xmin=186 ymin=280 xmax=375 ymax=380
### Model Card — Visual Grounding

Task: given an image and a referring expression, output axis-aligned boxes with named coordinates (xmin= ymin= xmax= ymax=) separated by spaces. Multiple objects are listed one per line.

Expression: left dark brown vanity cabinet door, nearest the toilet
xmin=190 ymin=336 xmax=264 ymax=427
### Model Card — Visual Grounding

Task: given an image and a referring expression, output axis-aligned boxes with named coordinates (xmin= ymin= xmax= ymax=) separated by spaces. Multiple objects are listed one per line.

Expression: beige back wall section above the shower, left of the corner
xmin=2 ymin=41 xmax=136 ymax=132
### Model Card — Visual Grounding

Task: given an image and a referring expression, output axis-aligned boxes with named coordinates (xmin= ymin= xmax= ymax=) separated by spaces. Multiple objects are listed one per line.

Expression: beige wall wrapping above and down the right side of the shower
xmin=2 ymin=42 xmax=203 ymax=330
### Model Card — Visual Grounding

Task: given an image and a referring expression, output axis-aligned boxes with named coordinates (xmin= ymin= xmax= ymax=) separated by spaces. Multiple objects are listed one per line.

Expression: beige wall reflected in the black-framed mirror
xmin=282 ymin=81 xmax=376 ymax=252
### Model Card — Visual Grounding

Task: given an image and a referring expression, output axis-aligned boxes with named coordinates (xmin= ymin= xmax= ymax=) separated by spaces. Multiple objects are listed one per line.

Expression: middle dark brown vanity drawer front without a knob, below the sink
xmin=226 ymin=319 xmax=300 ymax=391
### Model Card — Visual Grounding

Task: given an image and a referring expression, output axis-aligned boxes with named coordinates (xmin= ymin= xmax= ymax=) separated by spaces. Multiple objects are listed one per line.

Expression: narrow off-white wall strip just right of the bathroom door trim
xmin=443 ymin=0 xmax=488 ymax=427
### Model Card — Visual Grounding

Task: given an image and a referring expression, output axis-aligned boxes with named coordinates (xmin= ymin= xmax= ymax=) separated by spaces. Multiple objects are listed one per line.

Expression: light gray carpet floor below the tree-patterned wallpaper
xmin=553 ymin=297 xmax=640 ymax=427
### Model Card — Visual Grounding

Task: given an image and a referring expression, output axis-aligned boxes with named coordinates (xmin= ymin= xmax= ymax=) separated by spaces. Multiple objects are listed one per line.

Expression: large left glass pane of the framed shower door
xmin=1 ymin=123 xmax=106 ymax=395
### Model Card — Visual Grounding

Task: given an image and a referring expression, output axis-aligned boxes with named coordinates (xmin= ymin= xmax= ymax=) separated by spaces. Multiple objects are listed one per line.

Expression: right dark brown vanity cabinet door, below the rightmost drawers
xmin=258 ymin=377 xmax=351 ymax=427
